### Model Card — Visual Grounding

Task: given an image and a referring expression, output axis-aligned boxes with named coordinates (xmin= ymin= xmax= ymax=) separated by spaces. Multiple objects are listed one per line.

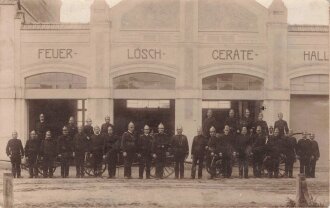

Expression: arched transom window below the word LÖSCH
xmin=114 ymin=73 xmax=175 ymax=89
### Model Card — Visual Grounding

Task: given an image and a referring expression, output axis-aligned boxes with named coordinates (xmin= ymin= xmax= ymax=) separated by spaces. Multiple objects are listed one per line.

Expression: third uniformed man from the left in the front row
xmin=40 ymin=131 xmax=57 ymax=178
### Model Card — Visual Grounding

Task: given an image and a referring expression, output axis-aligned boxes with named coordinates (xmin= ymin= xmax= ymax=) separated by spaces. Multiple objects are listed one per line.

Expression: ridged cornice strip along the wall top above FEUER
xmin=21 ymin=23 xmax=90 ymax=30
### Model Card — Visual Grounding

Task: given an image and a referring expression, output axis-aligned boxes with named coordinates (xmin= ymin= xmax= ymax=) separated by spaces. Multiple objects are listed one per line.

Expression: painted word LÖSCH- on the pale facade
xmin=127 ymin=48 xmax=165 ymax=60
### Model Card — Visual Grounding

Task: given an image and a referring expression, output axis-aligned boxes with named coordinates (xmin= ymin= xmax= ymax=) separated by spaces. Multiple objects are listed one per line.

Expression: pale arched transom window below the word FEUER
xmin=25 ymin=73 xmax=87 ymax=89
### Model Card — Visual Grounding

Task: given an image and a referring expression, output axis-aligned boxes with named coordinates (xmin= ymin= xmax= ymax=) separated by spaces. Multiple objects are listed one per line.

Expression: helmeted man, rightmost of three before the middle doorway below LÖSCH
xmin=152 ymin=123 xmax=170 ymax=179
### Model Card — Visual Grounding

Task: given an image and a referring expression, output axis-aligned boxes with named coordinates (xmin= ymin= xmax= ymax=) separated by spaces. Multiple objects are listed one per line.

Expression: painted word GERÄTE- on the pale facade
xmin=212 ymin=49 xmax=258 ymax=61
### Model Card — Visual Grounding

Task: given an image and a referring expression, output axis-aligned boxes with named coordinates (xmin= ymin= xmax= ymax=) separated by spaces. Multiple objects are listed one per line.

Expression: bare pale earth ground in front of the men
xmin=0 ymin=165 xmax=329 ymax=208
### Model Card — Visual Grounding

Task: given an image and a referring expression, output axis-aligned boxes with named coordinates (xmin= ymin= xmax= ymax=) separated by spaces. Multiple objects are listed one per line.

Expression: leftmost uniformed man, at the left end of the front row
xmin=6 ymin=131 xmax=24 ymax=178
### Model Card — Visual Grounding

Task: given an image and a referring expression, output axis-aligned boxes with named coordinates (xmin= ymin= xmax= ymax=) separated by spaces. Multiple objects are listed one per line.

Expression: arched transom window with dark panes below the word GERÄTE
xmin=203 ymin=74 xmax=264 ymax=90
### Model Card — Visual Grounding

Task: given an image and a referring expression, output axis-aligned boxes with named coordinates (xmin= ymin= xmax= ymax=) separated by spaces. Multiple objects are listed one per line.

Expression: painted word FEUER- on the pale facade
xmin=38 ymin=48 xmax=77 ymax=59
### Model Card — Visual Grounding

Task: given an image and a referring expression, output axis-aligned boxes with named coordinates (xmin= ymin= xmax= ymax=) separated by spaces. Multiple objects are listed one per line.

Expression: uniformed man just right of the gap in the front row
xmin=191 ymin=127 xmax=208 ymax=179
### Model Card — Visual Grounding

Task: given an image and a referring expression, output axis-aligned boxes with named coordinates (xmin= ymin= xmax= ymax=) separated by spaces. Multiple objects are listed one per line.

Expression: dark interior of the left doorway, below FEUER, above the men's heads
xmin=28 ymin=100 xmax=78 ymax=137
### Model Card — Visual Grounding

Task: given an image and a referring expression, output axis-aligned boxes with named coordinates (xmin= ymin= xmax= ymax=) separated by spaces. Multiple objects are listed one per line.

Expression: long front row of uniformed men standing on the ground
xmin=7 ymin=123 xmax=319 ymax=178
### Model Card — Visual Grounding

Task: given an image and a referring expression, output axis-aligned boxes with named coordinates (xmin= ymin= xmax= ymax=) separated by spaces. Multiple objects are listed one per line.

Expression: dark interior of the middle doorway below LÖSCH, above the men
xmin=114 ymin=100 xmax=175 ymax=135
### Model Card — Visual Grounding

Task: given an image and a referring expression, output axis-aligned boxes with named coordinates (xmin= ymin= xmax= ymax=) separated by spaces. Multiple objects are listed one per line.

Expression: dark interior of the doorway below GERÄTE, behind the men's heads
xmin=202 ymin=100 xmax=262 ymax=132
